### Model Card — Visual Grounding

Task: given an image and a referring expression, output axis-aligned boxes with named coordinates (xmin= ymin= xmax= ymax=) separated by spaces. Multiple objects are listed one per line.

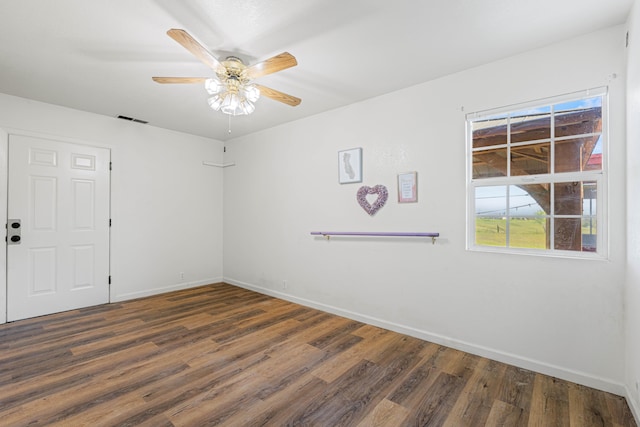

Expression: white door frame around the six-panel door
xmin=0 ymin=126 xmax=113 ymax=324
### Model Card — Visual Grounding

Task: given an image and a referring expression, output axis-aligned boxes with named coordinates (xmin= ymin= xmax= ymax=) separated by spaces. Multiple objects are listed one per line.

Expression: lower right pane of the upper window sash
xmin=554 ymin=135 xmax=602 ymax=173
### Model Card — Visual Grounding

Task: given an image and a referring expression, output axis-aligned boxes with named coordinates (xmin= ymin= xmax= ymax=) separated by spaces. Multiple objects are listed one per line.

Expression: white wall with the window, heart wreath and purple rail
xmin=224 ymin=27 xmax=625 ymax=393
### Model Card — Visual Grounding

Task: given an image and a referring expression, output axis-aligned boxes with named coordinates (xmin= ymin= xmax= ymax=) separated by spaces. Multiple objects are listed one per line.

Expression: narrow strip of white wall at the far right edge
xmin=625 ymin=2 xmax=640 ymax=420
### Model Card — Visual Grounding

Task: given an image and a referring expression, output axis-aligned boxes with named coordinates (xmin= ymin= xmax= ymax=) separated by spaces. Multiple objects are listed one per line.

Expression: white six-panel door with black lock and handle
xmin=7 ymin=135 xmax=111 ymax=321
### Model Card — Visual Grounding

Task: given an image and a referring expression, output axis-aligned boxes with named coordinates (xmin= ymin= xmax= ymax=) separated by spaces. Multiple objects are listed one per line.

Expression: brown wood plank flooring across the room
xmin=0 ymin=284 xmax=636 ymax=427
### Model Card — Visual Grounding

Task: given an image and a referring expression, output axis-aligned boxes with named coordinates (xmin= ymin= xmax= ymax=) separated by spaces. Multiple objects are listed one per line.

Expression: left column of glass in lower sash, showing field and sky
xmin=475 ymin=186 xmax=507 ymax=247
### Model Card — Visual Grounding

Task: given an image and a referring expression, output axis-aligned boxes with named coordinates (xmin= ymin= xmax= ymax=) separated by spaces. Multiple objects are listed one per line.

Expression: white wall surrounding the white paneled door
xmin=0 ymin=94 xmax=223 ymax=314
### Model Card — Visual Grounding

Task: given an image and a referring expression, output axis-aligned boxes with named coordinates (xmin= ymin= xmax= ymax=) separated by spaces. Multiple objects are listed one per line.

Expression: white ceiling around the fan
xmin=0 ymin=0 xmax=633 ymax=141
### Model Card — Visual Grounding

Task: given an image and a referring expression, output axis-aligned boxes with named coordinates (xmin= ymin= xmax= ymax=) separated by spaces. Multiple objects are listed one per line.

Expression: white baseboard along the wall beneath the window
xmin=223 ymin=277 xmax=624 ymax=398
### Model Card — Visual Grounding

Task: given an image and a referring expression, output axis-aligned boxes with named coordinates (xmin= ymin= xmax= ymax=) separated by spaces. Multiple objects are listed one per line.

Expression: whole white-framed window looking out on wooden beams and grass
xmin=467 ymin=88 xmax=607 ymax=257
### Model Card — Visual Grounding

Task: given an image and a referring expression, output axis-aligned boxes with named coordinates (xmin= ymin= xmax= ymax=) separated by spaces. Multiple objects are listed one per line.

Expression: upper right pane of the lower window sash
xmin=553 ymin=181 xmax=597 ymax=216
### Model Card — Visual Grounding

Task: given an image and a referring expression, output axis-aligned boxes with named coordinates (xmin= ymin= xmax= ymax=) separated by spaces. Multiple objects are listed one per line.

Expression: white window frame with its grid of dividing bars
xmin=465 ymin=87 xmax=609 ymax=259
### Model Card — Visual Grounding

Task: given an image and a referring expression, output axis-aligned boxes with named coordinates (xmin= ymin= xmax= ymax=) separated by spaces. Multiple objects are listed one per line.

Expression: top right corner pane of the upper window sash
xmin=554 ymin=96 xmax=602 ymax=138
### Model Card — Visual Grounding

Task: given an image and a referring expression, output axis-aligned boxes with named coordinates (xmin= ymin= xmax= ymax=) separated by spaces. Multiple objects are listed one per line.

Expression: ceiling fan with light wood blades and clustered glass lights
xmin=153 ymin=29 xmax=302 ymax=116
